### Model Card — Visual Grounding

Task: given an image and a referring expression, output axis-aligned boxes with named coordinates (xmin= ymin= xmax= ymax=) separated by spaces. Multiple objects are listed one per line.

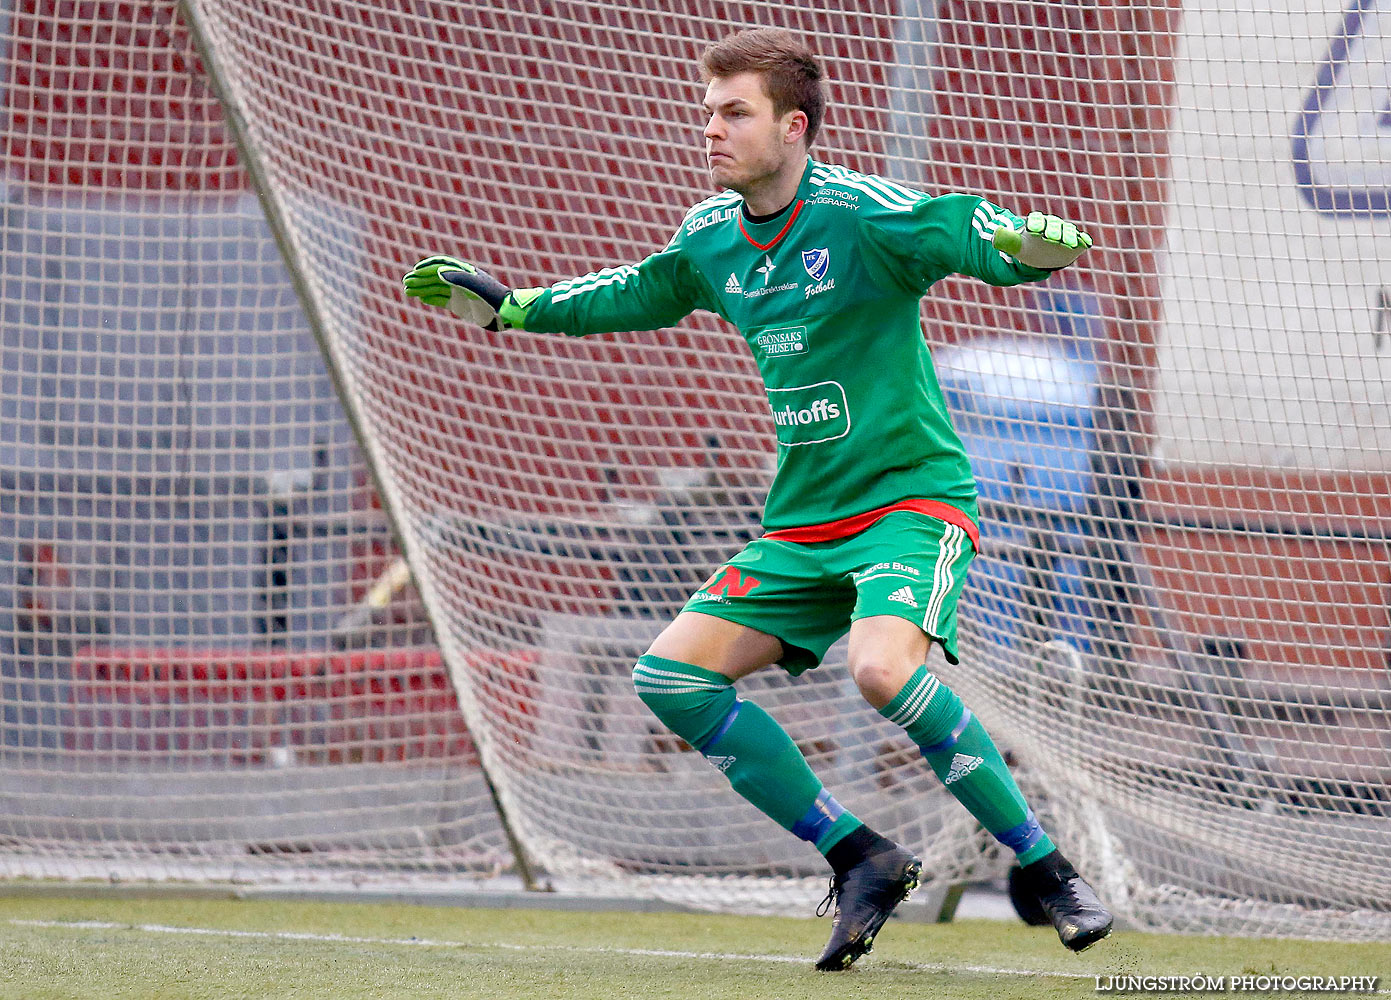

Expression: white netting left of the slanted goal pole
xmin=0 ymin=3 xmax=510 ymax=879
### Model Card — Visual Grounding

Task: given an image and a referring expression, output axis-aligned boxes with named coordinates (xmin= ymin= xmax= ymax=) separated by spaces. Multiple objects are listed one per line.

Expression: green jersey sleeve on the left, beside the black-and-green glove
xmin=514 ymin=238 xmax=709 ymax=337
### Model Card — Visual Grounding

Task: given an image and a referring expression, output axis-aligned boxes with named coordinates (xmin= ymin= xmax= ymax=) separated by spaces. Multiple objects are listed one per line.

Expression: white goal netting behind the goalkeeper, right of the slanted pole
xmin=4 ymin=0 xmax=1391 ymax=937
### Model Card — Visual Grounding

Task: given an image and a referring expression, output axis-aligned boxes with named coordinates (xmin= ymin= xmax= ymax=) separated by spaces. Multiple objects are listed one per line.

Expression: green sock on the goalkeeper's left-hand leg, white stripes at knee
xmin=633 ymin=655 xmax=861 ymax=854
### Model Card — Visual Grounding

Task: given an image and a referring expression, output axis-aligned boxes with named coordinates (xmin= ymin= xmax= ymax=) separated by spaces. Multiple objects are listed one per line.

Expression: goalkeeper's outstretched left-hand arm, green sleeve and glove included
xmin=402 ymin=248 xmax=704 ymax=337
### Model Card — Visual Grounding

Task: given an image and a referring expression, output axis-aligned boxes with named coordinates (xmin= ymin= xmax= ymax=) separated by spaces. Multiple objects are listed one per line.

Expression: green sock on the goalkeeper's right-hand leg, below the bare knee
xmin=879 ymin=666 xmax=1053 ymax=865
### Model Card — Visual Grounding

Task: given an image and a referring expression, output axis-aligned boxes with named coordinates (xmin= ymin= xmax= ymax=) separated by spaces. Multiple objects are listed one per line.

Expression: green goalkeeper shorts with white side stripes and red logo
xmin=682 ymin=510 xmax=975 ymax=675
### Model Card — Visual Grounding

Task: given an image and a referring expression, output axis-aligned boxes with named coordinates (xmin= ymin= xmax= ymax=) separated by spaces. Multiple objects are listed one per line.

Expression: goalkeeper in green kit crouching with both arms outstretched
xmin=405 ymin=28 xmax=1111 ymax=971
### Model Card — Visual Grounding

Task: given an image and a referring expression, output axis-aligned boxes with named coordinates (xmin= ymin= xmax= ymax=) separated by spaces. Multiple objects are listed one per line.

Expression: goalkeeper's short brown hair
xmin=700 ymin=28 xmax=826 ymax=146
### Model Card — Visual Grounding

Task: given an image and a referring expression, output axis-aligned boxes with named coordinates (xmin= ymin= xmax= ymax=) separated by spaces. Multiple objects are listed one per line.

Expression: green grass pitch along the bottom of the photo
xmin=0 ymin=897 xmax=1391 ymax=1000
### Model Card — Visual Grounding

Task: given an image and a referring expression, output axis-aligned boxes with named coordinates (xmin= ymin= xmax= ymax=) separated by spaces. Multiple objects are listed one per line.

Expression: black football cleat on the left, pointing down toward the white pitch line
xmin=817 ymin=844 xmax=922 ymax=972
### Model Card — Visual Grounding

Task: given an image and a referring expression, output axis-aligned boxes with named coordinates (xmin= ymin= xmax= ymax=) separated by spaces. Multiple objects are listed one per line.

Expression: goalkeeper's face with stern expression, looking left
xmin=702 ymin=72 xmax=805 ymax=192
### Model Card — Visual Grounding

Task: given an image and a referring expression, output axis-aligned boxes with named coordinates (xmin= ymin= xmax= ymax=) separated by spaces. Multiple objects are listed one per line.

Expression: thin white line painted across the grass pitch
xmin=10 ymin=919 xmax=1095 ymax=979
